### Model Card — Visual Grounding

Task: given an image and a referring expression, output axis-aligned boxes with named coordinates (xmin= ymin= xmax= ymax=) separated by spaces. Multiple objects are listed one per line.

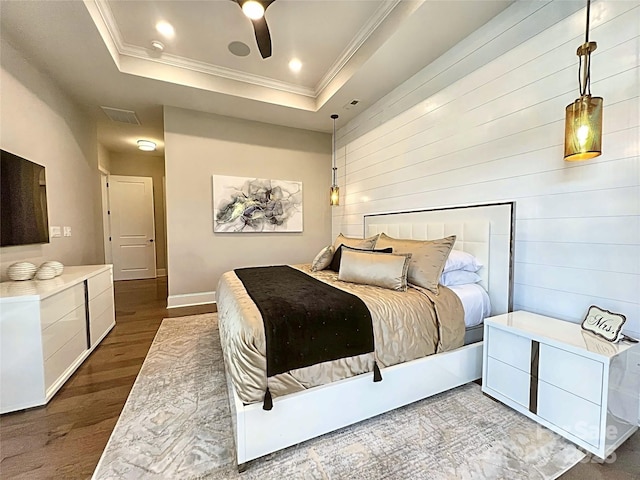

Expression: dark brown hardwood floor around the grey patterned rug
xmin=0 ymin=278 xmax=640 ymax=480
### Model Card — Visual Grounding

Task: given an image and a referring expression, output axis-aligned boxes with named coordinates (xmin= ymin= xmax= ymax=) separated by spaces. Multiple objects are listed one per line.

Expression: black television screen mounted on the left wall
xmin=0 ymin=150 xmax=49 ymax=247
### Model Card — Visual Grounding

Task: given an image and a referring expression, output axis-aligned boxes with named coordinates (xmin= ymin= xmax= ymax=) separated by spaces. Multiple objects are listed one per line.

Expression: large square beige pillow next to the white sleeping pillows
xmin=376 ymin=233 xmax=456 ymax=293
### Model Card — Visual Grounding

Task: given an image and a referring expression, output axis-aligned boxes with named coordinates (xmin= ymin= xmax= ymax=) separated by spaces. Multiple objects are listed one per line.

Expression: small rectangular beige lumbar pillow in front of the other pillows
xmin=338 ymin=249 xmax=411 ymax=292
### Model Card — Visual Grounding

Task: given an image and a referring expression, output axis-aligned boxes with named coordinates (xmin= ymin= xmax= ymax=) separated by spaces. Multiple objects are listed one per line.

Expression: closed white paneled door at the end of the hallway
xmin=109 ymin=175 xmax=156 ymax=280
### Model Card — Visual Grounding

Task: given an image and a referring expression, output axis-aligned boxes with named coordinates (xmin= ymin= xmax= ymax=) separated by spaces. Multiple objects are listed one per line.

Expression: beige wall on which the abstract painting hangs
xmin=164 ymin=107 xmax=331 ymax=306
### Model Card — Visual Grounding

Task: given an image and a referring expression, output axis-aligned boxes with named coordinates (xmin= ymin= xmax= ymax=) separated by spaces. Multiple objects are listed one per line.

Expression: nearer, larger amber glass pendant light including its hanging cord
xmin=564 ymin=0 xmax=602 ymax=162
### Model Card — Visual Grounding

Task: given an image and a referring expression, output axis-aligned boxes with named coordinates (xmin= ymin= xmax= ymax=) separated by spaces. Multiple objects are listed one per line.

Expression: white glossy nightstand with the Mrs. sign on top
xmin=482 ymin=311 xmax=640 ymax=458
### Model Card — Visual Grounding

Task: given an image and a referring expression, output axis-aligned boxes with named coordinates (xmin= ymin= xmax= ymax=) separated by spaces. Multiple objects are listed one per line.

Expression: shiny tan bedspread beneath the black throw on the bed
xmin=216 ymin=265 xmax=465 ymax=403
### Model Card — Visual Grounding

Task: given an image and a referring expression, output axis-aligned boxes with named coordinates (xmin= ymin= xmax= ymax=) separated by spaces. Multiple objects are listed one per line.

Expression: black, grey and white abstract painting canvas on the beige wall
xmin=213 ymin=175 xmax=302 ymax=232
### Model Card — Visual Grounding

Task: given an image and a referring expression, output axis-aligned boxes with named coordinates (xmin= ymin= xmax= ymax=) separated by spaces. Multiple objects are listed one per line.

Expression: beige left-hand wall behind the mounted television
xmin=0 ymin=38 xmax=104 ymax=280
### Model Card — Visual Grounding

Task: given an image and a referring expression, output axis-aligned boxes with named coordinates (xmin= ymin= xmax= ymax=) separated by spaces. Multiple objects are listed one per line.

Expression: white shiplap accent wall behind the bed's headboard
xmin=333 ymin=1 xmax=640 ymax=336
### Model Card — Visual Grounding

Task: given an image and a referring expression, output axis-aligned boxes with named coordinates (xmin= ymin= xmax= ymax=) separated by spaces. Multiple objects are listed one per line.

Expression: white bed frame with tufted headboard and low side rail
xmin=227 ymin=202 xmax=515 ymax=472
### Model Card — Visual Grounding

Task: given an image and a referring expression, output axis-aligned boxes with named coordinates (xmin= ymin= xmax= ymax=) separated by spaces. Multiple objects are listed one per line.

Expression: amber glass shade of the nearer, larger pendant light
xmin=564 ymin=95 xmax=602 ymax=162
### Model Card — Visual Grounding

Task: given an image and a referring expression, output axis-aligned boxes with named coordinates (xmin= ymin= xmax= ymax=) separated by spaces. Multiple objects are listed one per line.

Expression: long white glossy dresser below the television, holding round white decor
xmin=0 ymin=265 xmax=115 ymax=413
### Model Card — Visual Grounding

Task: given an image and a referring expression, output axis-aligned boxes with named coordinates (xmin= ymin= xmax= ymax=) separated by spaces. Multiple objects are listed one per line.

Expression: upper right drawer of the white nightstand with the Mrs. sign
xmin=538 ymin=344 xmax=604 ymax=405
